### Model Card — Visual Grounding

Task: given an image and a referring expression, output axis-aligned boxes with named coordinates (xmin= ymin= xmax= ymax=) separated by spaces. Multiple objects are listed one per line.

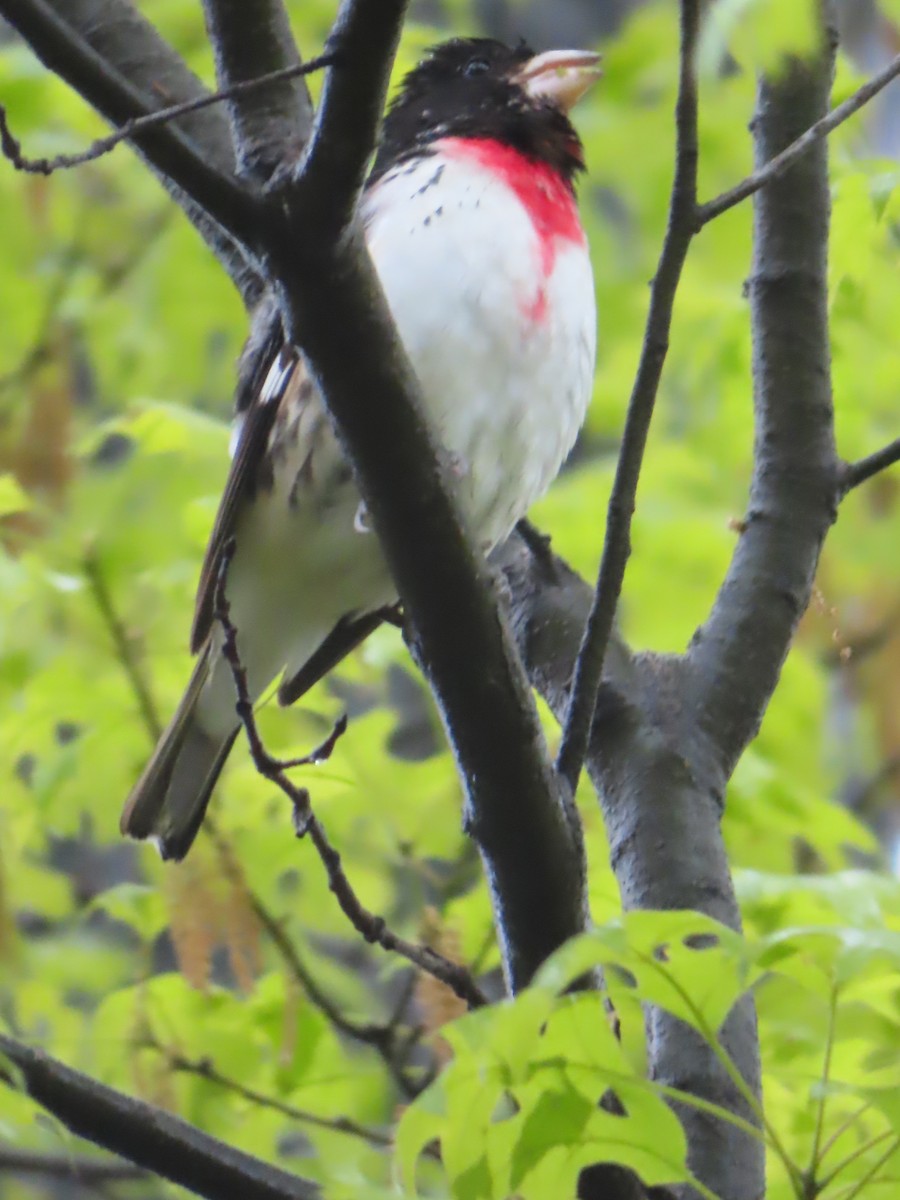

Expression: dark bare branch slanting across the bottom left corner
xmin=0 ymin=1034 xmax=320 ymax=1200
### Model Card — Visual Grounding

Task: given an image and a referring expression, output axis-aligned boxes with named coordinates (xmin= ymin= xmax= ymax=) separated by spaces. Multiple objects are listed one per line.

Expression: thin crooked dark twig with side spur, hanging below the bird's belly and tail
xmin=215 ymin=539 xmax=487 ymax=1008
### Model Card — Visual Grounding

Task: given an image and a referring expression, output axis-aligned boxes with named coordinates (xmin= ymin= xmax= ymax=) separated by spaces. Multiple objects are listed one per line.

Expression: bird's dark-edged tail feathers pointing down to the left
xmin=119 ymin=644 xmax=240 ymax=859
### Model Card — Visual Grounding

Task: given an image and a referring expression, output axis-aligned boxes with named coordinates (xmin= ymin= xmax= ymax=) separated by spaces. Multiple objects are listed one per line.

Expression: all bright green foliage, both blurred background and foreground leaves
xmin=0 ymin=0 xmax=900 ymax=1200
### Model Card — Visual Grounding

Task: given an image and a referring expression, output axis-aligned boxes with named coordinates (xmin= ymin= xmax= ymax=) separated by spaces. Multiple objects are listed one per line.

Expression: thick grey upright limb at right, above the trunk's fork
xmin=688 ymin=34 xmax=840 ymax=778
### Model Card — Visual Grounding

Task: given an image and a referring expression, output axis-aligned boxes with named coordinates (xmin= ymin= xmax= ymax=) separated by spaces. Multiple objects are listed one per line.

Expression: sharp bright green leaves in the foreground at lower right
xmin=396 ymin=907 xmax=900 ymax=1200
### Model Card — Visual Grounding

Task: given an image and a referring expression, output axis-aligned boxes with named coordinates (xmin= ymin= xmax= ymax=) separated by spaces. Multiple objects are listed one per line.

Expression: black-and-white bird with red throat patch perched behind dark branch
xmin=120 ymin=37 xmax=601 ymax=860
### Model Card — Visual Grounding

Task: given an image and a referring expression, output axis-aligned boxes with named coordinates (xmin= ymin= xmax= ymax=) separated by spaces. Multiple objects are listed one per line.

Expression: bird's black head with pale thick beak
xmin=372 ymin=37 xmax=599 ymax=181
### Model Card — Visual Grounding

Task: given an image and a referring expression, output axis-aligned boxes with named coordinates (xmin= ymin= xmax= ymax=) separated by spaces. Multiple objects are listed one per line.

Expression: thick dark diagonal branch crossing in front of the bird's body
xmin=264 ymin=0 xmax=584 ymax=989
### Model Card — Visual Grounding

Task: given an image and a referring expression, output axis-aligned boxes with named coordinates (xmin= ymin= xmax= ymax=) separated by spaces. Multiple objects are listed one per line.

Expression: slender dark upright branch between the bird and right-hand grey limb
xmin=557 ymin=0 xmax=701 ymax=792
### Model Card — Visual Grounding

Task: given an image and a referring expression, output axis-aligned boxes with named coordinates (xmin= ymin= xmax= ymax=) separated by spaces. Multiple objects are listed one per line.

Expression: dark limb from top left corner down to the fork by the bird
xmin=0 ymin=0 xmax=258 ymax=270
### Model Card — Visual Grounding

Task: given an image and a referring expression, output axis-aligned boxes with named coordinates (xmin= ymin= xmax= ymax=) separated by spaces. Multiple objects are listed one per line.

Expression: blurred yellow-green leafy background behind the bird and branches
xmin=0 ymin=0 xmax=900 ymax=1200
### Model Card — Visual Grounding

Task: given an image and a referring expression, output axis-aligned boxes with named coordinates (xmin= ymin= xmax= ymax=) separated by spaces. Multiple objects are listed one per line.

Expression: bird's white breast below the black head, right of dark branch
xmin=364 ymin=144 xmax=596 ymax=546
